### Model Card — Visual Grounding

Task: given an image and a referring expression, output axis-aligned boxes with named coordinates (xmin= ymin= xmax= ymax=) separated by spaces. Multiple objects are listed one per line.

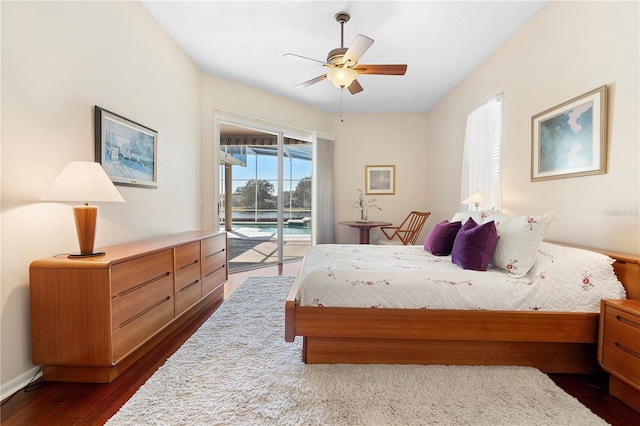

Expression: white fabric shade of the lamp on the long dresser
xmin=40 ymin=161 xmax=124 ymax=203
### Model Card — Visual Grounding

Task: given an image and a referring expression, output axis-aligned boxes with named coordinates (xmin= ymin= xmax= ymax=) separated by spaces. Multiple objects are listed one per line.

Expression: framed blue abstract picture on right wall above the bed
xmin=531 ymin=86 xmax=607 ymax=181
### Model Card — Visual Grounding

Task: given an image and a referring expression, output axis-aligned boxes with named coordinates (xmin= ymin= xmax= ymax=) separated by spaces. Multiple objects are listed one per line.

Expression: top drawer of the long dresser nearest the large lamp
xmin=111 ymin=249 xmax=173 ymax=297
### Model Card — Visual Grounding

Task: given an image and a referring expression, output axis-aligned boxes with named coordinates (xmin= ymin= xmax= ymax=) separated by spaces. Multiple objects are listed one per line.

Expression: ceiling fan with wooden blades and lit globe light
xmin=284 ymin=12 xmax=407 ymax=95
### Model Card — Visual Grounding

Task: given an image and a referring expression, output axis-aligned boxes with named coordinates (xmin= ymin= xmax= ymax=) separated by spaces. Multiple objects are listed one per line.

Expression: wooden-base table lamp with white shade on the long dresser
xmin=40 ymin=161 xmax=124 ymax=257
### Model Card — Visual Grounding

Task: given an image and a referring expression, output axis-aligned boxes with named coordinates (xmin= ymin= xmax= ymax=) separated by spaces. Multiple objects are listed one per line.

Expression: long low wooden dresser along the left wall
xmin=29 ymin=231 xmax=228 ymax=383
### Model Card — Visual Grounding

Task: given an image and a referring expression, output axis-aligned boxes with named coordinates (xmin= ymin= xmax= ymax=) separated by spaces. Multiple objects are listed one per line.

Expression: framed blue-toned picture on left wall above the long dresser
xmin=95 ymin=105 xmax=158 ymax=188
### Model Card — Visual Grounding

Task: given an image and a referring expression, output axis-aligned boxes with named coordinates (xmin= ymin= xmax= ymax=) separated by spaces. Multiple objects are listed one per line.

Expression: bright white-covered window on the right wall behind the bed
xmin=461 ymin=94 xmax=502 ymax=210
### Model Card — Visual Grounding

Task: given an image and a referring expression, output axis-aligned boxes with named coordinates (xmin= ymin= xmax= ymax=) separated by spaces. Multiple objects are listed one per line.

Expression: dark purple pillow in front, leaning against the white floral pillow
xmin=451 ymin=218 xmax=498 ymax=271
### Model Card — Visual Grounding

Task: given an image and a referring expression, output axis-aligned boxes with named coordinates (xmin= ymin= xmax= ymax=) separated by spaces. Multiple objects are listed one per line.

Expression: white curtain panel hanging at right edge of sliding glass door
xmin=311 ymin=138 xmax=336 ymax=244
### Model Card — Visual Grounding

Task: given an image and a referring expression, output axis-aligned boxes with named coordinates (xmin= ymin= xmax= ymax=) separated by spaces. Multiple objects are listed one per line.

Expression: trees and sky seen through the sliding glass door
xmin=220 ymin=149 xmax=311 ymax=222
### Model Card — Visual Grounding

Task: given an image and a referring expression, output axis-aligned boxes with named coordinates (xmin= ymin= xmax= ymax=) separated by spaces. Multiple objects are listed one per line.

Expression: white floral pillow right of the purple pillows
xmin=484 ymin=213 xmax=553 ymax=278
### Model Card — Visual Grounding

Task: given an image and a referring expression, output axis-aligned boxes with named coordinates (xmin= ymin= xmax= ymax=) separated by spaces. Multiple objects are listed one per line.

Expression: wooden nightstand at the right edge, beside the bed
xmin=598 ymin=300 xmax=640 ymax=411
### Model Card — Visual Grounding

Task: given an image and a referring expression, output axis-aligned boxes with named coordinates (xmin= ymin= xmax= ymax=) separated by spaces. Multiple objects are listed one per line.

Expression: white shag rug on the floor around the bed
xmin=107 ymin=277 xmax=607 ymax=426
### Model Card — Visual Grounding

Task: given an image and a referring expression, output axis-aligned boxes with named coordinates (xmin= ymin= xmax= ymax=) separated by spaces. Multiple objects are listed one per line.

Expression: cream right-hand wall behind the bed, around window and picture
xmin=426 ymin=1 xmax=640 ymax=253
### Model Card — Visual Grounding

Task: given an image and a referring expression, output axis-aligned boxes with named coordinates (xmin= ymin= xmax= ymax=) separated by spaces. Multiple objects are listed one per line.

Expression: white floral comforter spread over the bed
xmin=296 ymin=243 xmax=626 ymax=312
